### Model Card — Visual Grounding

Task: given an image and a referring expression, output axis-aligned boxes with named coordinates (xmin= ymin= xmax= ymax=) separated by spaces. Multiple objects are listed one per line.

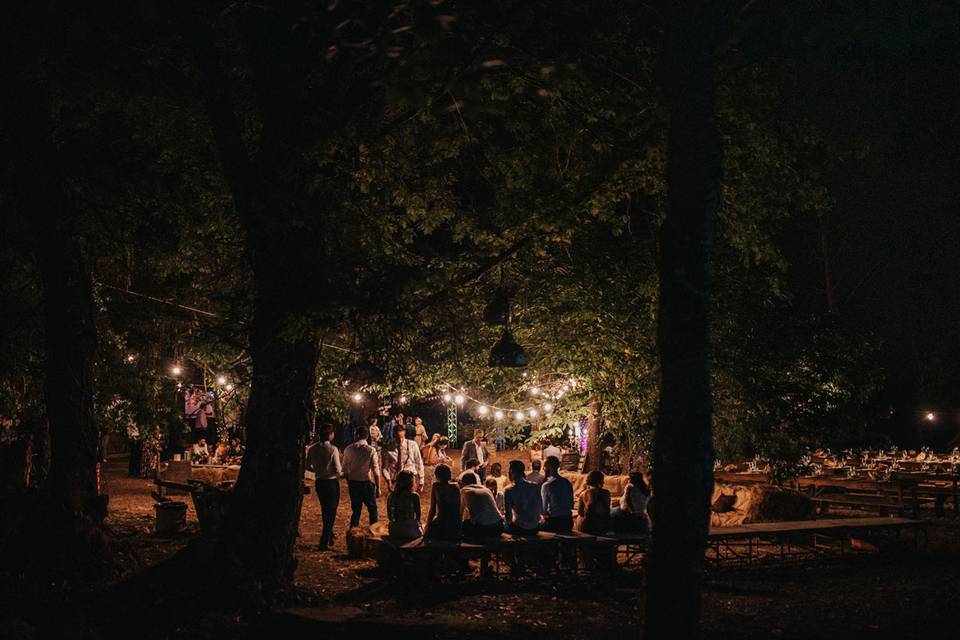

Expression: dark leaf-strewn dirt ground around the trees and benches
xmin=0 ymin=460 xmax=960 ymax=640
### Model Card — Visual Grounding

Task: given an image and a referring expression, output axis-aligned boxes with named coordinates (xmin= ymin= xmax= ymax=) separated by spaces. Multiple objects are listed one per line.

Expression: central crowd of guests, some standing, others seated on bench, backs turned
xmin=307 ymin=414 xmax=650 ymax=549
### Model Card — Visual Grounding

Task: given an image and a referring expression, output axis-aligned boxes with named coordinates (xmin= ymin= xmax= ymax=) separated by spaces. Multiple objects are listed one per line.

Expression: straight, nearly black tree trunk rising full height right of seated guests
xmin=646 ymin=0 xmax=721 ymax=639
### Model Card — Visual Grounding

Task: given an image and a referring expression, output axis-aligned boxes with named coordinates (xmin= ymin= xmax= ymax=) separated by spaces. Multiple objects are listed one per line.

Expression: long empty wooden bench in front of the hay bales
xmin=707 ymin=517 xmax=927 ymax=565
